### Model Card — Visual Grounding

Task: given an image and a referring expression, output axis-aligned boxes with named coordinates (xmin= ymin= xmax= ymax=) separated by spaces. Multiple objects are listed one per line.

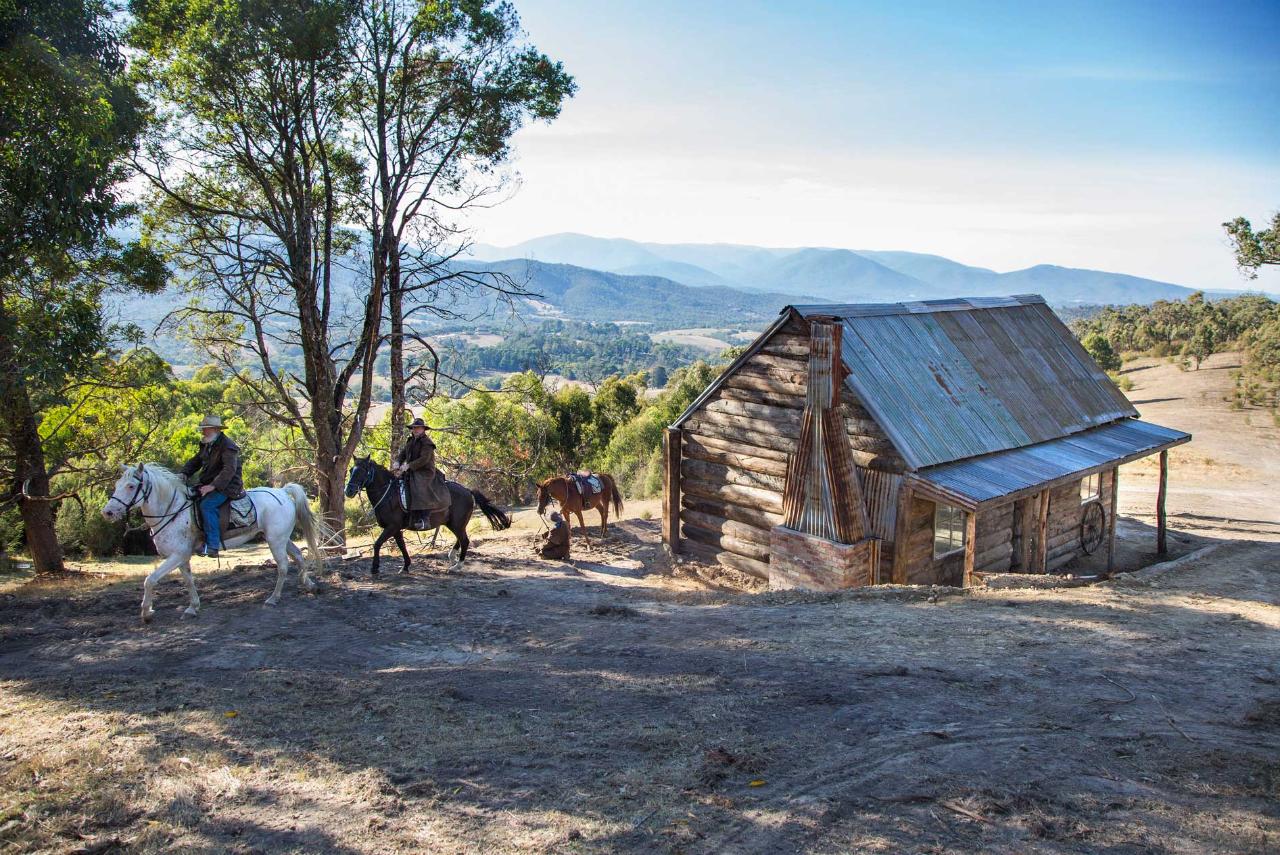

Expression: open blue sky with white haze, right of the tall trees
xmin=475 ymin=0 xmax=1280 ymax=291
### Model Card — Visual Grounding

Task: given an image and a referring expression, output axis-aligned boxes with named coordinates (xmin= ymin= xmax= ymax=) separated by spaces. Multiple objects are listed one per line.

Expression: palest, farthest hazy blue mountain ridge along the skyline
xmin=472 ymin=233 xmax=1196 ymax=306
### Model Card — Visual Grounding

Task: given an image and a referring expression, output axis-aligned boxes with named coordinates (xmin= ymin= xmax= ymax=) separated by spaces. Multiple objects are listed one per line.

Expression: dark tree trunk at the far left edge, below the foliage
xmin=0 ymin=298 xmax=63 ymax=573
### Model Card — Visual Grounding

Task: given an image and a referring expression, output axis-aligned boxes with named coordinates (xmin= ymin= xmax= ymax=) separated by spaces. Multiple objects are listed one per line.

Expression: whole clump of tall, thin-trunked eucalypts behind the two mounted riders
xmin=131 ymin=0 xmax=572 ymax=540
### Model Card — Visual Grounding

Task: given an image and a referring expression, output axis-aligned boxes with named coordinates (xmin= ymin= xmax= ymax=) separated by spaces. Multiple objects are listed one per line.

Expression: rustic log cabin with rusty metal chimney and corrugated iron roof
xmin=663 ymin=294 xmax=1190 ymax=590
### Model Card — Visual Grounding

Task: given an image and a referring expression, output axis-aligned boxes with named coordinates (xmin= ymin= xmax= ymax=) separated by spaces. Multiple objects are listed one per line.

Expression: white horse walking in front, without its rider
xmin=102 ymin=463 xmax=326 ymax=623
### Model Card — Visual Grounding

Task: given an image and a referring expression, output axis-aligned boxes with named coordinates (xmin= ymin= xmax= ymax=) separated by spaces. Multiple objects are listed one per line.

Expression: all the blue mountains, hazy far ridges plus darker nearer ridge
xmin=113 ymin=234 xmax=1208 ymax=373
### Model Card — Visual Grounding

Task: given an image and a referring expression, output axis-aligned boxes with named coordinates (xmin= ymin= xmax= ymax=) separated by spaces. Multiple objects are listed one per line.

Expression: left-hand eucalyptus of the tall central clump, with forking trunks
xmin=129 ymin=0 xmax=373 ymax=532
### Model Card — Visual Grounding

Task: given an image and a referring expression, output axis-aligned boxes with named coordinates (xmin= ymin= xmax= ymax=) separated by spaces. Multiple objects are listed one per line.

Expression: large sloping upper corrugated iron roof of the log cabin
xmin=791 ymin=294 xmax=1138 ymax=470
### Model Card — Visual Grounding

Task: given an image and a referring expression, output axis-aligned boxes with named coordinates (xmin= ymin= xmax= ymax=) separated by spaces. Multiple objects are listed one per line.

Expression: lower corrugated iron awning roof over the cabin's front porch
xmin=915 ymin=419 xmax=1190 ymax=506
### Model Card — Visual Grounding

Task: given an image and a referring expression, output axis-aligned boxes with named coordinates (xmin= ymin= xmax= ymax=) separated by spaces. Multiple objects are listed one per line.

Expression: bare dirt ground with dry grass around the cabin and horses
xmin=0 ymin=350 xmax=1280 ymax=852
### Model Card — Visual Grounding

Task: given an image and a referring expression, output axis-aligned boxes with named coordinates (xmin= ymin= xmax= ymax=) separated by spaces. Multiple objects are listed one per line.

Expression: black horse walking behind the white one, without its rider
xmin=347 ymin=457 xmax=511 ymax=576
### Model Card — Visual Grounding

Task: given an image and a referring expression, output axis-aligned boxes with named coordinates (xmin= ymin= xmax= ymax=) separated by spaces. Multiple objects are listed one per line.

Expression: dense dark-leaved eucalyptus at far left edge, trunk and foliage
xmin=0 ymin=0 xmax=164 ymax=571
